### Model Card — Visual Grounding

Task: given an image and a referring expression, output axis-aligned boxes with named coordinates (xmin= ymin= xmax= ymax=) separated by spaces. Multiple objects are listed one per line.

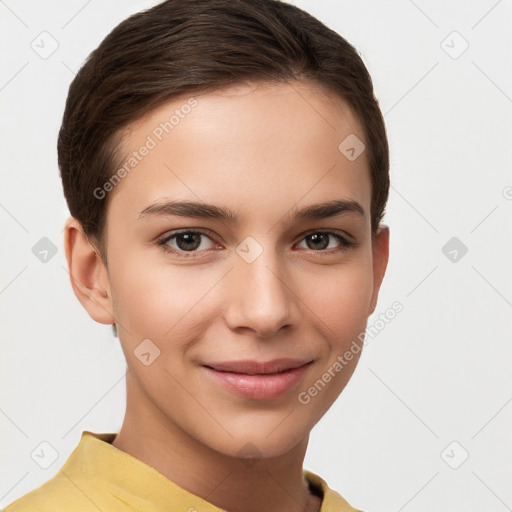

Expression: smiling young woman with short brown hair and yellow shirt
xmin=5 ymin=0 xmax=389 ymax=512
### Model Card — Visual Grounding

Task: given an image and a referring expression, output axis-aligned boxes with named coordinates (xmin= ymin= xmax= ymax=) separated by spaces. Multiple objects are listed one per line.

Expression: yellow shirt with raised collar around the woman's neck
xmin=3 ymin=430 xmax=364 ymax=512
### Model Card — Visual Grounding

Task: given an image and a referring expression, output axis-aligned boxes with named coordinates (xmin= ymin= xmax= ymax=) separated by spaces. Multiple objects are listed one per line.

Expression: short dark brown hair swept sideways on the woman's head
xmin=58 ymin=0 xmax=389 ymax=262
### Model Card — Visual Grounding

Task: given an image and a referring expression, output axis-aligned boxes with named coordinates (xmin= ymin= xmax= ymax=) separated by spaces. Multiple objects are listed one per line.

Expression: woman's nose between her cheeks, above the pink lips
xmin=225 ymin=248 xmax=300 ymax=338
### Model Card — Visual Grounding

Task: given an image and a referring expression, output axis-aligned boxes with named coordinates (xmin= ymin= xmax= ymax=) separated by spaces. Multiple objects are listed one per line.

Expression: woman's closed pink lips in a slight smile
xmin=203 ymin=359 xmax=312 ymax=400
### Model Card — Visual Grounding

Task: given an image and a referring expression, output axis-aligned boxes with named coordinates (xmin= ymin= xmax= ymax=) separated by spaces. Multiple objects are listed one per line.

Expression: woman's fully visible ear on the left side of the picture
xmin=64 ymin=217 xmax=115 ymax=324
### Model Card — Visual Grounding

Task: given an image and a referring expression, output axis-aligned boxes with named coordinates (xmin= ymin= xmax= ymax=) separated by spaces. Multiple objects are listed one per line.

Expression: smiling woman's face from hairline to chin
xmin=84 ymin=83 xmax=387 ymax=457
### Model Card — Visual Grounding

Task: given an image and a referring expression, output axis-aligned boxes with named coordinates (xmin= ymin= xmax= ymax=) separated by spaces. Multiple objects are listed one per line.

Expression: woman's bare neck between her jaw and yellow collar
xmin=112 ymin=371 xmax=321 ymax=512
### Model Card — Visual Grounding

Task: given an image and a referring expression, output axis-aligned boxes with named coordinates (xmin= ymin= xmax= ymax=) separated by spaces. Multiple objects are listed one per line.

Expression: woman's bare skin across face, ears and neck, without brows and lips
xmin=65 ymin=83 xmax=389 ymax=512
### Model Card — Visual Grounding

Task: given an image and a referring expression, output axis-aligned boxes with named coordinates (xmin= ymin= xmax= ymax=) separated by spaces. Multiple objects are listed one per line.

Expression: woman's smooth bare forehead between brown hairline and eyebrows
xmin=109 ymin=82 xmax=371 ymax=226
